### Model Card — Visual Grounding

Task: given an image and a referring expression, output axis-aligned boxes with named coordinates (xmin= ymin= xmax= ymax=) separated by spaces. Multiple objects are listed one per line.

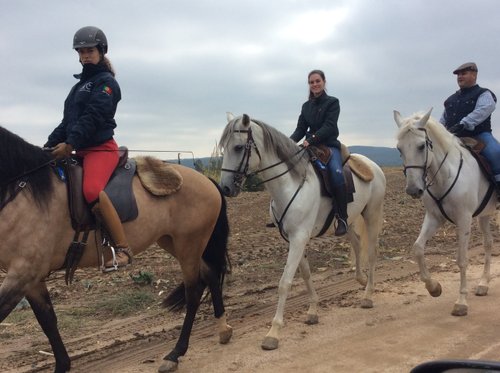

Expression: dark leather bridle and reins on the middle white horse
xmin=221 ymin=127 xmax=305 ymax=189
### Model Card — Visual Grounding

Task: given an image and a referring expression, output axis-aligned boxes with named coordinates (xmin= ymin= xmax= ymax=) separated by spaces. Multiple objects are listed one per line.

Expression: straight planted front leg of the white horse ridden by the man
xmin=451 ymin=218 xmax=472 ymax=316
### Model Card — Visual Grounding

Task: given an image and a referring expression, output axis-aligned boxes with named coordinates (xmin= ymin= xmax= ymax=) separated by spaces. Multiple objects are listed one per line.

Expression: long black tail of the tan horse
xmin=162 ymin=179 xmax=231 ymax=311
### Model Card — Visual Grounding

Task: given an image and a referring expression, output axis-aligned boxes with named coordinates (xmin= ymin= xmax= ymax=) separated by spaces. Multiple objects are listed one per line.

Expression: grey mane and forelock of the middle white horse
xmin=219 ymin=116 xmax=309 ymax=176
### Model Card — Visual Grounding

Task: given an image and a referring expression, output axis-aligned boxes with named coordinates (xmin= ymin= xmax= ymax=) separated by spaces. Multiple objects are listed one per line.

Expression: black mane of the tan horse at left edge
xmin=0 ymin=126 xmax=53 ymax=206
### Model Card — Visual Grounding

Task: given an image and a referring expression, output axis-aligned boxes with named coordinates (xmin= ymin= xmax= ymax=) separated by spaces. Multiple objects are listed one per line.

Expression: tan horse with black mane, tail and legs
xmin=0 ymin=127 xmax=232 ymax=373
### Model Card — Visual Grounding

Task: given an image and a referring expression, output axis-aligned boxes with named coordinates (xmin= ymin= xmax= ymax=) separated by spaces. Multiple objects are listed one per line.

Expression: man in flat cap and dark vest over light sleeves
xmin=439 ymin=62 xmax=500 ymax=198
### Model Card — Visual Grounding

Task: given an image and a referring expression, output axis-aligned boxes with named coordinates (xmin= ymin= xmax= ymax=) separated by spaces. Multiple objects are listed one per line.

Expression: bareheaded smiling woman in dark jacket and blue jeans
xmin=290 ymin=70 xmax=347 ymax=236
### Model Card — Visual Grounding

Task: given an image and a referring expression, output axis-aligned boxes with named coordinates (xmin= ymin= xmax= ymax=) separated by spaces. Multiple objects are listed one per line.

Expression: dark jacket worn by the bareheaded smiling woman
xmin=290 ymin=92 xmax=340 ymax=148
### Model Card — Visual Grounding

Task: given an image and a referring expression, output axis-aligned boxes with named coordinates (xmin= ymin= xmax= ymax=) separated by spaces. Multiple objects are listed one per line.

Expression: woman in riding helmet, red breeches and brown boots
xmin=44 ymin=26 xmax=132 ymax=270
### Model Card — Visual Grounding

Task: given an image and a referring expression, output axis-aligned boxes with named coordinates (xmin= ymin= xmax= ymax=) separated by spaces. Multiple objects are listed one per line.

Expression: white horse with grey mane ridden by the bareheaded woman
xmin=219 ymin=113 xmax=386 ymax=350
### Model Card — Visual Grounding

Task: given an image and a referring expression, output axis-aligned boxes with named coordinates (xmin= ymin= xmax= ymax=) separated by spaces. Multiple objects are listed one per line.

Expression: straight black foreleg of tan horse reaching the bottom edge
xmin=26 ymin=282 xmax=71 ymax=373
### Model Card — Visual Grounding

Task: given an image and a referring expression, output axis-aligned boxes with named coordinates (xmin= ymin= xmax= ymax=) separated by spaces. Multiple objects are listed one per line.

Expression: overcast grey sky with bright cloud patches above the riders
xmin=0 ymin=0 xmax=500 ymax=159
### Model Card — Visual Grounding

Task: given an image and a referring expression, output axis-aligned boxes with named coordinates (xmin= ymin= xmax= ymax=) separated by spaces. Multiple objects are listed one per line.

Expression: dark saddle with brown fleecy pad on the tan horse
xmin=56 ymin=147 xmax=182 ymax=284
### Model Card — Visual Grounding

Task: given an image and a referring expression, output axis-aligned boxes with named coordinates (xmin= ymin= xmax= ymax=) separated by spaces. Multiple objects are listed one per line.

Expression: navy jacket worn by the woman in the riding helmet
xmin=44 ymin=64 xmax=121 ymax=150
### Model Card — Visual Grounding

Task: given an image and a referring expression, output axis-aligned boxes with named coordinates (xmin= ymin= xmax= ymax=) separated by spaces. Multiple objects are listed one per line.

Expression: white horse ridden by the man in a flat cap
xmin=394 ymin=109 xmax=496 ymax=316
